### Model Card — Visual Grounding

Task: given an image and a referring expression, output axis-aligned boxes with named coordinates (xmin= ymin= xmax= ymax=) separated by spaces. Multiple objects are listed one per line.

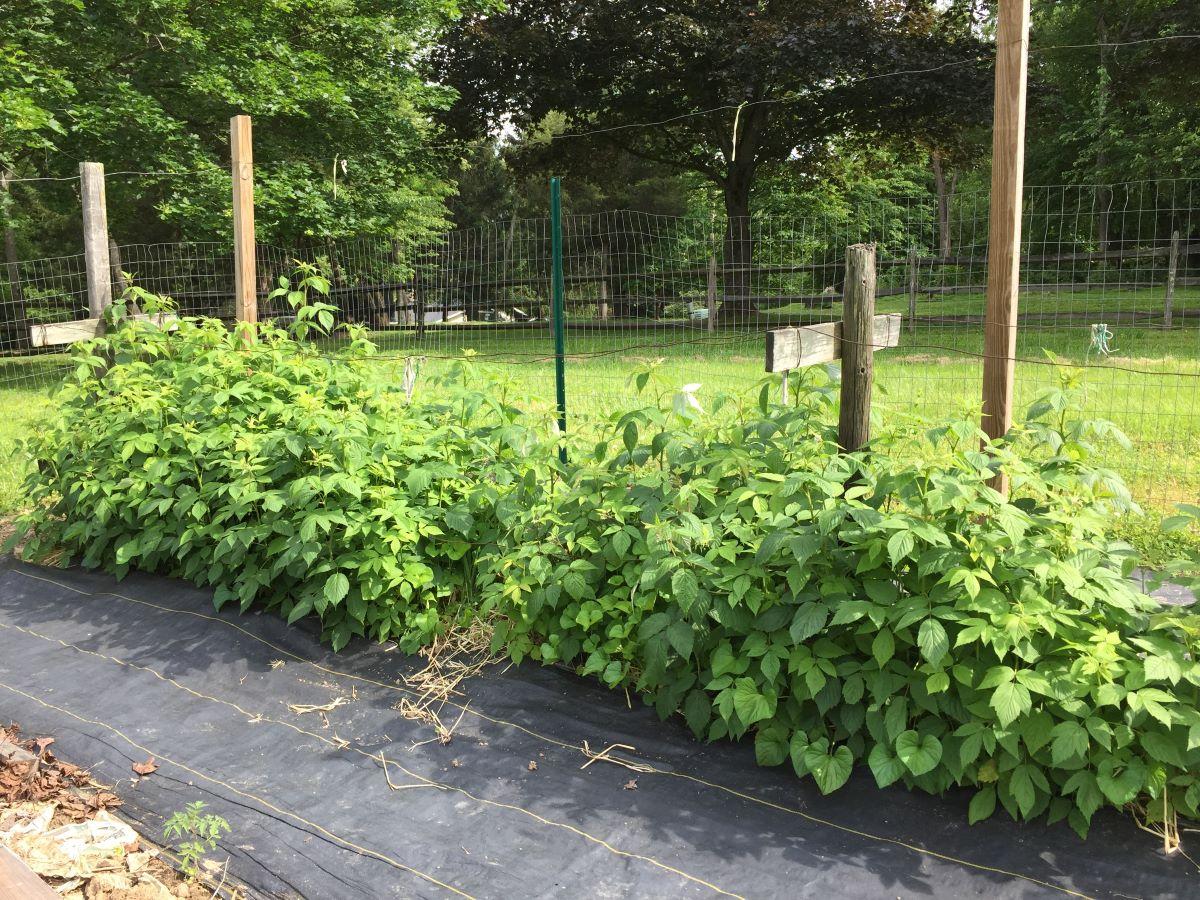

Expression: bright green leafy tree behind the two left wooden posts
xmin=0 ymin=0 xmax=472 ymax=255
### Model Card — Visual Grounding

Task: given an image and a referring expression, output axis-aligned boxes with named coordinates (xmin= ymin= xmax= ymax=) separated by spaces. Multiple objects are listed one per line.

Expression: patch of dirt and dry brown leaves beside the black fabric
xmin=0 ymin=725 xmax=235 ymax=900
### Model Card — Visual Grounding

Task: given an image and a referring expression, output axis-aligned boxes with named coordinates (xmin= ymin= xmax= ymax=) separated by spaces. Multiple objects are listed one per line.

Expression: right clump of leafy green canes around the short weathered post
xmin=480 ymin=367 xmax=1200 ymax=834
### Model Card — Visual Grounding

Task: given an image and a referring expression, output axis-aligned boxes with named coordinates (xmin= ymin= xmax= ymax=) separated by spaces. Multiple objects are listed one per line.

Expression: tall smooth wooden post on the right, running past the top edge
xmin=982 ymin=0 xmax=1030 ymax=491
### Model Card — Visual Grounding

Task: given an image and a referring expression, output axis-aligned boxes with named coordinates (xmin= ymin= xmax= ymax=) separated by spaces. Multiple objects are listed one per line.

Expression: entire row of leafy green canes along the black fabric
xmin=11 ymin=283 xmax=1200 ymax=834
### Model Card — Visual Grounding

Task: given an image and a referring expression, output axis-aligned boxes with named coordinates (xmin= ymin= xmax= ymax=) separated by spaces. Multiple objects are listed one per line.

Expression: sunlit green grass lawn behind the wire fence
xmin=0 ymin=288 xmax=1200 ymax=556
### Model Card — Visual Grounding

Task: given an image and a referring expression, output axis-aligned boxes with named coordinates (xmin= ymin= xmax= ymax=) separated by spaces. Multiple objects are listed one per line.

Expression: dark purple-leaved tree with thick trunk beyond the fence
xmin=434 ymin=0 xmax=990 ymax=316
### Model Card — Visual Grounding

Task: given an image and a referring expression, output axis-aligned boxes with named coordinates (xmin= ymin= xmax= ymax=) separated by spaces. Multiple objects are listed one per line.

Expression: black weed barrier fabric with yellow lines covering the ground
xmin=0 ymin=562 xmax=1200 ymax=898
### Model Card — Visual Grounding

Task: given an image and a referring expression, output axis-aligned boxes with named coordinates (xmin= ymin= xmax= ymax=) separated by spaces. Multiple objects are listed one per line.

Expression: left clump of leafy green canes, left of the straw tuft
xmin=11 ymin=278 xmax=545 ymax=649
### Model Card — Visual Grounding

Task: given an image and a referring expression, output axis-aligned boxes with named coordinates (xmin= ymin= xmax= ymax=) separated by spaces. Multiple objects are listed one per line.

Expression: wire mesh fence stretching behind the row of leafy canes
xmin=0 ymin=180 xmax=1200 ymax=506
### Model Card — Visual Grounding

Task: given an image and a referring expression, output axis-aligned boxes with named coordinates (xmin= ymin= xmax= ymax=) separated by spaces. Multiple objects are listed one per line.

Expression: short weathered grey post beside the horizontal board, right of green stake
xmin=838 ymin=244 xmax=875 ymax=452
